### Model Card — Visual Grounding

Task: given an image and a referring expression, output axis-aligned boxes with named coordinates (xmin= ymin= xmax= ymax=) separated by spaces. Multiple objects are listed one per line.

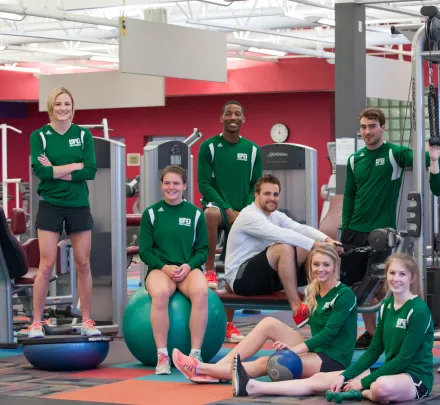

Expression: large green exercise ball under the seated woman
xmin=122 ymin=288 xmax=226 ymax=366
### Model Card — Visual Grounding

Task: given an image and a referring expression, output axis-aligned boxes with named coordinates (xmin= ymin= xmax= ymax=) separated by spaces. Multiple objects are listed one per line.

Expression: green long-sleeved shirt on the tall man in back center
xmin=197 ymin=134 xmax=263 ymax=211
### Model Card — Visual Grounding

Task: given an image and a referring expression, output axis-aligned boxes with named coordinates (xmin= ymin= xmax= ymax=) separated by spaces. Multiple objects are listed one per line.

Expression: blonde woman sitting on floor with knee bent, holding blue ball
xmin=173 ymin=244 xmax=357 ymax=384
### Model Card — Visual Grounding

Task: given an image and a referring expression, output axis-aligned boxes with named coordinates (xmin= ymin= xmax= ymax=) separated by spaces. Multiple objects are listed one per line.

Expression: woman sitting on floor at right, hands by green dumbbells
xmin=233 ymin=253 xmax=434 ymax=403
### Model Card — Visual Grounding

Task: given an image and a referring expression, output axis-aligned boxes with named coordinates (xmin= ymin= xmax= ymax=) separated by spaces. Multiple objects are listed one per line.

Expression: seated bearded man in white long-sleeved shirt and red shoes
xmin=225 ymin=174 xmax=342 ymax=327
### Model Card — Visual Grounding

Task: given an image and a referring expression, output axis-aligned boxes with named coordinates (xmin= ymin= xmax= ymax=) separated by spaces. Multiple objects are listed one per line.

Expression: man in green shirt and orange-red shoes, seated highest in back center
xmin=197 ymin=100 xmax=263 ymax=342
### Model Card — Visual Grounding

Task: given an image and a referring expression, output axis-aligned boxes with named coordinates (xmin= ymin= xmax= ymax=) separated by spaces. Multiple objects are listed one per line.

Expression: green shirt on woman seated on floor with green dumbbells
xmin=342 ymin=296 xmax=434 ymax=390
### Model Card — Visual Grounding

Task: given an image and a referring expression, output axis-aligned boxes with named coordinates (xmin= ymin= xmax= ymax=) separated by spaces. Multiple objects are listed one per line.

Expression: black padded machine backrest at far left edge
xmin=0 ymin=208 xmax=29 ymax=279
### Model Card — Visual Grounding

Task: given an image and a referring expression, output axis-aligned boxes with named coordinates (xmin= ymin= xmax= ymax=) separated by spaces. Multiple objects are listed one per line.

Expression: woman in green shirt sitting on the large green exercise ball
xmin=139 ymin=166 xmax=208 ymax=374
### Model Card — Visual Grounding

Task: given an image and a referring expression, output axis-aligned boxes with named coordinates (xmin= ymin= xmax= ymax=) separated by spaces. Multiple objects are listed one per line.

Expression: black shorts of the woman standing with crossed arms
xmin=35 ymin=200 xmax=93 ymax=235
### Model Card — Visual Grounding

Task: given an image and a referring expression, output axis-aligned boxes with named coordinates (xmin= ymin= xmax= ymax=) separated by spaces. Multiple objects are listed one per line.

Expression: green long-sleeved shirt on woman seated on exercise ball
xmin=139 ymin=200 xmax=209 ymax=271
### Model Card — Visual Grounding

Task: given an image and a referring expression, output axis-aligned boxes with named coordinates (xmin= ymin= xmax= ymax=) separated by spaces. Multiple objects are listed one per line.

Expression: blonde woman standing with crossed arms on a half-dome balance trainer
xmin=28 ymin=87 xmax=101 ymax=338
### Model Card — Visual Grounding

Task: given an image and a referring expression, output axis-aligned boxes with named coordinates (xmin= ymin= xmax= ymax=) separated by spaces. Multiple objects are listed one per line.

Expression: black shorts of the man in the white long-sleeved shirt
xmin=232 ymin=247 xmax=307 ymax=295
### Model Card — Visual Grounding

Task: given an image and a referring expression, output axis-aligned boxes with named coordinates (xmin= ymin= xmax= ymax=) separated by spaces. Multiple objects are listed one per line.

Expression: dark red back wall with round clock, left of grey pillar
xmin=3 ymin=92 xmax=335 ymax=216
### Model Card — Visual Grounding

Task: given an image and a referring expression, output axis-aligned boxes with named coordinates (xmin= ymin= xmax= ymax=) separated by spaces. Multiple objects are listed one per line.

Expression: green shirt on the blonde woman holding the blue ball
xmin=304 ymin=283 xmax=357 ymax=368
